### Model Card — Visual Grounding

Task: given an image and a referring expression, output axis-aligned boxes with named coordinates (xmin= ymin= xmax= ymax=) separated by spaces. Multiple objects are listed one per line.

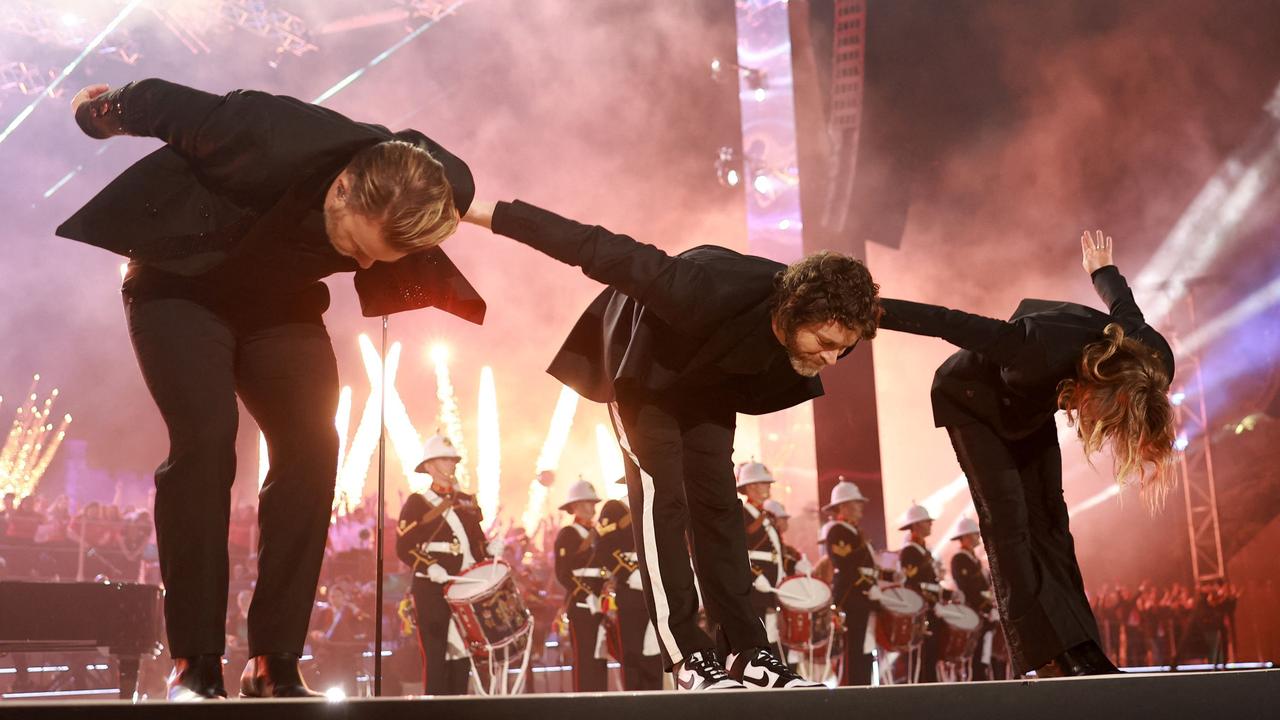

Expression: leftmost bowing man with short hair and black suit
xmin=58 ymin=78 xmax=484 ymax=700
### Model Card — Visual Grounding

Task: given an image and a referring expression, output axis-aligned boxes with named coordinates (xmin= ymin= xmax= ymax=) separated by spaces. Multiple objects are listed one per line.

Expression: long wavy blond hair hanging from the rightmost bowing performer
xmin=1057 ymin=323 xmax=1178 ymax=512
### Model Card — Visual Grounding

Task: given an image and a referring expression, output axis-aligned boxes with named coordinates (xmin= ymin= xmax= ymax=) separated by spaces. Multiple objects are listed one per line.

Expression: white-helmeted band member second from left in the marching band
xmin=556 ymin=480 xmax=609 ymax=692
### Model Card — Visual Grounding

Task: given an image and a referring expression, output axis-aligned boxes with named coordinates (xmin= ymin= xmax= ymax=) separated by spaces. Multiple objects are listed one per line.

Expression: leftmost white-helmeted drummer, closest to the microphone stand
xmin=396 ymin=436 xmax=502 ymax=694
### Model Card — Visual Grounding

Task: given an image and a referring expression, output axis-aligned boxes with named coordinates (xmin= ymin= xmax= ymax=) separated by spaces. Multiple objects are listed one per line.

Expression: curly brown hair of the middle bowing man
xmin=771 ymin=250 xmax=882 ymax=340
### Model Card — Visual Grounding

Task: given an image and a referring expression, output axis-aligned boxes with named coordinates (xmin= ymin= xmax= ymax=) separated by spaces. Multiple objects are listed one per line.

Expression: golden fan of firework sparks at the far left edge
xmin=0 ymin=374 xmax=72 ymax=500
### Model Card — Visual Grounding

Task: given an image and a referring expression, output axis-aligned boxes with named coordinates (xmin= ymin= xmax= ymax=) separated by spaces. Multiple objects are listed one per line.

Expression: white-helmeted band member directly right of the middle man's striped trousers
xmin=737 ymin=460 xmax=786 ymax=657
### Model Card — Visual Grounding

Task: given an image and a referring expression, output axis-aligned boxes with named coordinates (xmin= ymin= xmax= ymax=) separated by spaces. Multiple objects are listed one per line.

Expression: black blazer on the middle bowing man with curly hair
xmin=493 ymin=200 xmax=822 ymax=415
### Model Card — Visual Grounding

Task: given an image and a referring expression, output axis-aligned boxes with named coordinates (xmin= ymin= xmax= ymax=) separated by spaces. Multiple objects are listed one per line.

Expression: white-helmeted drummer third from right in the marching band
xmin=820 ymin=480 xmax=879 ymax=685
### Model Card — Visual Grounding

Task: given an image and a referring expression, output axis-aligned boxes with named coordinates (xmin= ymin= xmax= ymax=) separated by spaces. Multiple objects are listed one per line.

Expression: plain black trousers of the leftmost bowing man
xmin=125 ymin=300 xmax=338 ymax=657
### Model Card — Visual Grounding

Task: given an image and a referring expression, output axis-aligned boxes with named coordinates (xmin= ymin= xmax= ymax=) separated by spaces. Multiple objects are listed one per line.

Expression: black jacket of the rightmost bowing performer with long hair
xmin=879 ymin=265 xmax=1174 ymax=438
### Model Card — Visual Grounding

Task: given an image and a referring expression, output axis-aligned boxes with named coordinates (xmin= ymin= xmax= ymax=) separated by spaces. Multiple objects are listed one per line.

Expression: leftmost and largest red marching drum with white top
xmin=444 ymin=560 xmax=530 ymax=655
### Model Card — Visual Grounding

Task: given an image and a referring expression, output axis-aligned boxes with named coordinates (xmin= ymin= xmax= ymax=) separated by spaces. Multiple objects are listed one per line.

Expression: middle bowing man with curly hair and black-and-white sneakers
xmin=463 ymin=201 xmax=879 ymax=689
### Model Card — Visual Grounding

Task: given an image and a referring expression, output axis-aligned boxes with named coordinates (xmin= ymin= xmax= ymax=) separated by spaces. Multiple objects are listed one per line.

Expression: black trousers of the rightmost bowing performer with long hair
xmin=947 ymin=421 xmax=1098 ymax=675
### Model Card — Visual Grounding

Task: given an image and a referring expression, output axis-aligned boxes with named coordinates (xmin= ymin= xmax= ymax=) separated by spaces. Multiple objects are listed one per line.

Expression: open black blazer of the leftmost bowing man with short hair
xmin=56 ymin=78 xmax=485 ymax=323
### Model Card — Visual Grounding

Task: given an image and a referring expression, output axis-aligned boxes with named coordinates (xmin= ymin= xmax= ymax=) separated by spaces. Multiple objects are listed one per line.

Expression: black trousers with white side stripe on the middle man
xmin=611 ymin=398 xmax=768 ymax=671
